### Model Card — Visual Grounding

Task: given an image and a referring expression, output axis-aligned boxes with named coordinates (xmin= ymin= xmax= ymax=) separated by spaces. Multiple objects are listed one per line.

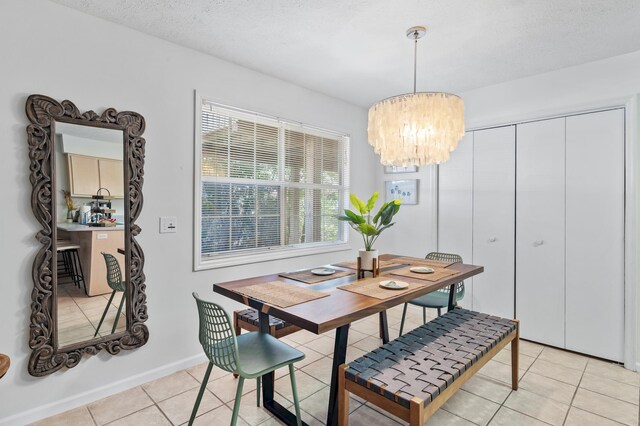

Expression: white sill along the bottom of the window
xmin=193 ymin=243 xmax=351 ymax=271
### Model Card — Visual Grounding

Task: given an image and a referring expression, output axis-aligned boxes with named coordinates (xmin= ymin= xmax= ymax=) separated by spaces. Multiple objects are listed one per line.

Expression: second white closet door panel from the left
xmin=473 ymin=126 xmax=516 ymax=318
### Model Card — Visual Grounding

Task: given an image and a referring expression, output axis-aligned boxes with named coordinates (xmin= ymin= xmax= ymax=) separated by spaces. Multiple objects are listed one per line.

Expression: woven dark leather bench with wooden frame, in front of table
xmin=338 ymin=308 xmax=519 ymax=426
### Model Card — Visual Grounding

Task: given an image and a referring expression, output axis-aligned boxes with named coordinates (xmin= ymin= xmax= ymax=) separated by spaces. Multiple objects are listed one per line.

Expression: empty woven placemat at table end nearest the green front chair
xmin=236 ymin=281 xmax=329 ymax=308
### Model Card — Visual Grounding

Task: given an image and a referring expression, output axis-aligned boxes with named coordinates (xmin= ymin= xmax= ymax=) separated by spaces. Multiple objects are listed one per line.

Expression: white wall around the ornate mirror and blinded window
xmin=0 ymin=0 xmax=374 ymax=424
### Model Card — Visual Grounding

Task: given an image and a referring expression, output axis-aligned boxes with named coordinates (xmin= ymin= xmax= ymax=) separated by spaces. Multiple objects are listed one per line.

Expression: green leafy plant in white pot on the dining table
xmin=338 ymin=192 xmax=402 ymax=271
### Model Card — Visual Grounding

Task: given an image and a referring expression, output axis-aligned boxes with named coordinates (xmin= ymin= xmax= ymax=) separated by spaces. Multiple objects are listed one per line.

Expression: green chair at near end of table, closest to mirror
xmin=189 ymin=292 xmax=305 ymax=426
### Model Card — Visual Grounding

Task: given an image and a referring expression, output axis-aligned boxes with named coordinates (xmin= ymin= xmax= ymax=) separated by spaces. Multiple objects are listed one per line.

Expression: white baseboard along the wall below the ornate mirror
xmin=0 ymin=353 xmax=207 ymax=426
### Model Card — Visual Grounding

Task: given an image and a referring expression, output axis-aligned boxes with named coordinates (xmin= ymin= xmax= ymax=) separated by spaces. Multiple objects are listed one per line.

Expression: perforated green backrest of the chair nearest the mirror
xmin=193 ymin=292 xmax=239 ymax=373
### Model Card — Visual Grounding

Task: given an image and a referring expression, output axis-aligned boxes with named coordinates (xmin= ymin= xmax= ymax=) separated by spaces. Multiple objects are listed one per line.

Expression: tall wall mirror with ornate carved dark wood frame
xmin=26 ymin=95 xmax=148 ymax=376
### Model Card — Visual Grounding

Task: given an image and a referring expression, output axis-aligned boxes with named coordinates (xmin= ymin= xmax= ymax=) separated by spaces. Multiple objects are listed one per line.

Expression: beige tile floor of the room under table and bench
xmin=37 ymin=307 xmax=640 ymax=426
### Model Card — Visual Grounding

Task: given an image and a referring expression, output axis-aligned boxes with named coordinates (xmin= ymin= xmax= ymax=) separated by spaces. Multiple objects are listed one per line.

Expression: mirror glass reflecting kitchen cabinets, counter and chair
xmin=54 ymin=122 xmax=127 ymax=347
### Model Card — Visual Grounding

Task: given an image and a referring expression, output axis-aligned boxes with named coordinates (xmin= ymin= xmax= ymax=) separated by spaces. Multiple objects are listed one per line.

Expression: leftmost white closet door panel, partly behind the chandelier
xmin=438 ymin=132 xmax=473 ymax=309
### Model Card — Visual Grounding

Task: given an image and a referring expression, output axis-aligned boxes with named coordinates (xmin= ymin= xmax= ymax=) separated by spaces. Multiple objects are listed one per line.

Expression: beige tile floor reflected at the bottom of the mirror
xmin=58 ymin=283 xmax=127 ymax=346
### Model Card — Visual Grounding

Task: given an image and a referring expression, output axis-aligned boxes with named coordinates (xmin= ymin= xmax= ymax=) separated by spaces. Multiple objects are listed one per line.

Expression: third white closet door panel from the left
xmin=516 ymin=118 xmax=565 ymax=347
